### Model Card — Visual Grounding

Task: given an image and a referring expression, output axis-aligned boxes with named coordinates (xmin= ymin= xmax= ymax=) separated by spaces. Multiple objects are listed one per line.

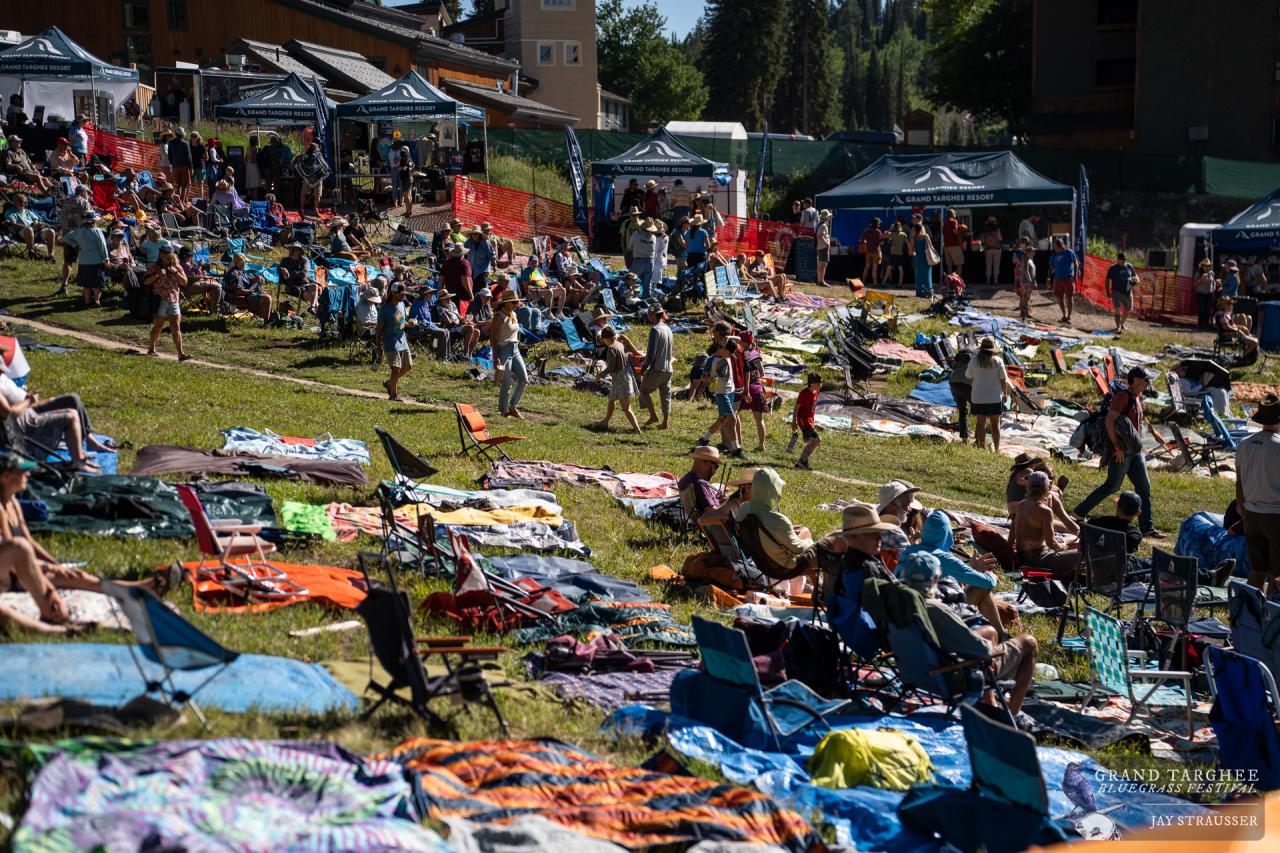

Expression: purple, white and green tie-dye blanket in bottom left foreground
xmin=13 ymin=738 xmax=451 ymax=853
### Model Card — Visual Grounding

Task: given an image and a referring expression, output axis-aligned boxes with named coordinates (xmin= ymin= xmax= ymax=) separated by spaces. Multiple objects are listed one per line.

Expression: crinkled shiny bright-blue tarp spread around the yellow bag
xmin=607 ymin=706 xmax=1210 ymax=853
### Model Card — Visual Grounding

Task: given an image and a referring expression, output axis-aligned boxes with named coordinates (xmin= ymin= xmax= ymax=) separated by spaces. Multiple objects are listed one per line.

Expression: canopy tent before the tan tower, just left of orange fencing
xmin=334 ymin=70 xmax=489 ymax=202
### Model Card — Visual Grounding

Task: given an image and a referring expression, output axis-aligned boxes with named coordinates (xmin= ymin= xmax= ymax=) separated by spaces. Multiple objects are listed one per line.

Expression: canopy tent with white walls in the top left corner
xmin=0 ymin=27 xmax=138 ymax=127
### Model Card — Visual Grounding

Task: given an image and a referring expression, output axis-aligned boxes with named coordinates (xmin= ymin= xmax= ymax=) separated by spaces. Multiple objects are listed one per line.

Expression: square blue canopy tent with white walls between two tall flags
xmin=591 ymin=127 xmax=732 ymax=251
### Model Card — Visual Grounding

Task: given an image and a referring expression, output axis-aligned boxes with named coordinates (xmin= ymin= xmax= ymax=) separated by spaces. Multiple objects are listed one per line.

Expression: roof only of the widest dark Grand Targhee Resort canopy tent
xmin=817 ymin=151 xmax=1075 ymax=209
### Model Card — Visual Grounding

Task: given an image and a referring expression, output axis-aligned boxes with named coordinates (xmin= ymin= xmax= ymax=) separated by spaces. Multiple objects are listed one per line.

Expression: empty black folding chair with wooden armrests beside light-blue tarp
xmin=356 ymin=553 xmax=509 ymax=736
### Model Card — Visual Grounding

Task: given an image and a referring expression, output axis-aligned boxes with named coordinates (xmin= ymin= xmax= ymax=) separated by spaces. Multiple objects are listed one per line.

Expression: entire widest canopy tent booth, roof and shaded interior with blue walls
xmin=815 ymin=151 xmax=1075 ymax=282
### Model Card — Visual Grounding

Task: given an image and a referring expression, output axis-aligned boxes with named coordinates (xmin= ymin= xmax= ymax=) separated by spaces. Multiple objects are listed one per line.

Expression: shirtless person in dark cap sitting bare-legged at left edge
xmin=0 ymin=453 xmax=173 ymax=625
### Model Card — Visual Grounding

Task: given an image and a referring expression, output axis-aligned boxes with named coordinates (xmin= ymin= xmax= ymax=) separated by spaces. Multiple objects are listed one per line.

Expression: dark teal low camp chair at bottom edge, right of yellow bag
xmin=897 ymin=707 xmax=1070 ymax=853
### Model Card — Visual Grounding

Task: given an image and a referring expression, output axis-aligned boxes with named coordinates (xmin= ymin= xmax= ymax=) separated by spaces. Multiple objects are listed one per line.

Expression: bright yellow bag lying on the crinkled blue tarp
xmin=809 ymin=729 xmax=933 ymax=790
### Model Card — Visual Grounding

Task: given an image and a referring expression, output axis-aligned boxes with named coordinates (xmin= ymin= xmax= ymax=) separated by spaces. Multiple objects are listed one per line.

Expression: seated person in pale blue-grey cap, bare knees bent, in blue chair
xmin=897 ymin=551 xmax=1039 ymax=715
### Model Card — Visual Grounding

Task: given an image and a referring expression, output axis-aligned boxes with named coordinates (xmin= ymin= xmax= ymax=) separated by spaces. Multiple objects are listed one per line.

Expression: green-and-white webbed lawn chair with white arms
xmin=1080 ymin=607 xmax=1196 ymax=735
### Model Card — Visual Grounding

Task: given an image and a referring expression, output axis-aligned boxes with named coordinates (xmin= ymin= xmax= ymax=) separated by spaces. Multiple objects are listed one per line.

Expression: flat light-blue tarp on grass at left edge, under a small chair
xmin=0 ymin=643 xmax=360 ymax=713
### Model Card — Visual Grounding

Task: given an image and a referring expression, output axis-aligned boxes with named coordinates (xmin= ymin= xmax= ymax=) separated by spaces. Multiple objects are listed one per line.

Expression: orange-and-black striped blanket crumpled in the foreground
xmin=376 ymin=738 xmax=819 ymax=853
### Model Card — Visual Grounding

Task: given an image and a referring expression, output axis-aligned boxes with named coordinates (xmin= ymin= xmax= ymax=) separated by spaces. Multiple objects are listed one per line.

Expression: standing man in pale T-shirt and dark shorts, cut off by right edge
xmin=1235 ymin=394 xmax=1280 ymax=592
